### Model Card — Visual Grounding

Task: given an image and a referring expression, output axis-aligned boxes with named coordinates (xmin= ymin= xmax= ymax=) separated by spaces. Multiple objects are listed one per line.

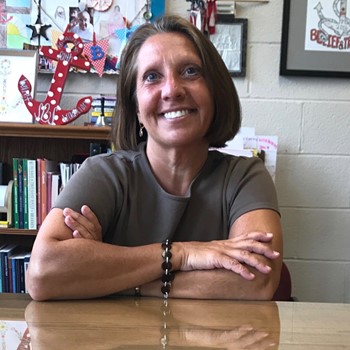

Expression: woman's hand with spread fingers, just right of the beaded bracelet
xmin=176 ymin=232 xmax=280 ymax=280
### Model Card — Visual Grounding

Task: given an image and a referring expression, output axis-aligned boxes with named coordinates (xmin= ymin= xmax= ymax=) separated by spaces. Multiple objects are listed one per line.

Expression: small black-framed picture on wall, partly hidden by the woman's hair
xmin=210 ymin=14 xmax=248 ymax=77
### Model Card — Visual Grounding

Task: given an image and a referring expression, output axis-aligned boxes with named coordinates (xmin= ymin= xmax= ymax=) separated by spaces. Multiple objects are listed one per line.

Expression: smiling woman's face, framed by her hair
xmin=136 ymin=33 xmax=214 ymax=151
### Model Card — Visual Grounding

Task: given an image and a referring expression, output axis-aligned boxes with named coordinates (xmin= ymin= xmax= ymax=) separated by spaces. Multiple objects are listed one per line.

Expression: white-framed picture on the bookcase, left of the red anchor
xmin=0 ymin=49 xmax=38 ymax=123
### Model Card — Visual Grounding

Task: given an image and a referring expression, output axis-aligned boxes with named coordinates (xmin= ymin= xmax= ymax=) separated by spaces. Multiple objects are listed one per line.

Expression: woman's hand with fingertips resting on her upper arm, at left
xmin=63 ymin=205 xmax=102 ymax=241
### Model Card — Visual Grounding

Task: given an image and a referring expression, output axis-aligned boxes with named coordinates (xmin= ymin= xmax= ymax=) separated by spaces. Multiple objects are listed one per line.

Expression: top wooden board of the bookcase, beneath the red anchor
xmin=0 ymin=123 xmax=111 ymax=140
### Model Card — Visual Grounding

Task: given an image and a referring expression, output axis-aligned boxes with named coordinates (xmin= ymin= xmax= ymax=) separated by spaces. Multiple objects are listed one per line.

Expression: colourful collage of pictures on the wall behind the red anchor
xmin=0 ymin=0 xmax=164 ymax=73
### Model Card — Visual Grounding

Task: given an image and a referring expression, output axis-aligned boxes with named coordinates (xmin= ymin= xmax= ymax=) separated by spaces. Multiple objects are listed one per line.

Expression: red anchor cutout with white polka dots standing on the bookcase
xmin=18 ymin=25 xmax=92 ymax=125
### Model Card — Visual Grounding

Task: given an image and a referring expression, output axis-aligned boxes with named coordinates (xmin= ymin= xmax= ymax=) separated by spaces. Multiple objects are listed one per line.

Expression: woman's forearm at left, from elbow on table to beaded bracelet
xmin=27 ymin=239 xmax=162 ymax=300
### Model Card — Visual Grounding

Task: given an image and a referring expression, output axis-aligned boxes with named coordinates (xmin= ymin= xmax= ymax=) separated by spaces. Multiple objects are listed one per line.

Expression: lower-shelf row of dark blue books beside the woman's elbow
xmin=0 ymin=244 xmax=30 ymax=293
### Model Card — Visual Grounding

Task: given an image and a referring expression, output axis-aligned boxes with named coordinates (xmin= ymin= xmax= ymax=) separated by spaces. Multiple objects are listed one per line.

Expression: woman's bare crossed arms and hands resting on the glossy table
xmin=27 ymin=206 xmax=282 ymax=300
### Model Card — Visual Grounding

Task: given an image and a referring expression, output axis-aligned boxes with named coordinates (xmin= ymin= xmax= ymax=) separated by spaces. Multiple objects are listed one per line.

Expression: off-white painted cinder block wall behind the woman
xmin=38 ymin=0 xmax=350 ymax=303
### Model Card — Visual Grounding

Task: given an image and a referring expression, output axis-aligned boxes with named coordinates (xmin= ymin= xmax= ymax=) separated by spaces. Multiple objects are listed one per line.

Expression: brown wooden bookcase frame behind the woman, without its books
xmin=0 ymin=123 xmax=111 ymax=246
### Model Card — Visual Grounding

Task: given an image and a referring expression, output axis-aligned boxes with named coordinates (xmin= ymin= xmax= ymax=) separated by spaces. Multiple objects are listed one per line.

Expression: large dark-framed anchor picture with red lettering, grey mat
xmin=280 ymin=0 xmax=350 ymax=77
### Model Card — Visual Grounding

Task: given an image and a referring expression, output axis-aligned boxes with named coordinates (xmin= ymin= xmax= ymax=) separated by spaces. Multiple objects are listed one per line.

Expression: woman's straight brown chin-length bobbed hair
xmin=112 ymin=16 xmax=241 ymax=150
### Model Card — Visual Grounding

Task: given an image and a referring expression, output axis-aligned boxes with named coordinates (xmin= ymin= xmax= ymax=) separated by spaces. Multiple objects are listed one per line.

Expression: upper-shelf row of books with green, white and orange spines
xmin=12 ymin=158 xmax=80 ymax=230
